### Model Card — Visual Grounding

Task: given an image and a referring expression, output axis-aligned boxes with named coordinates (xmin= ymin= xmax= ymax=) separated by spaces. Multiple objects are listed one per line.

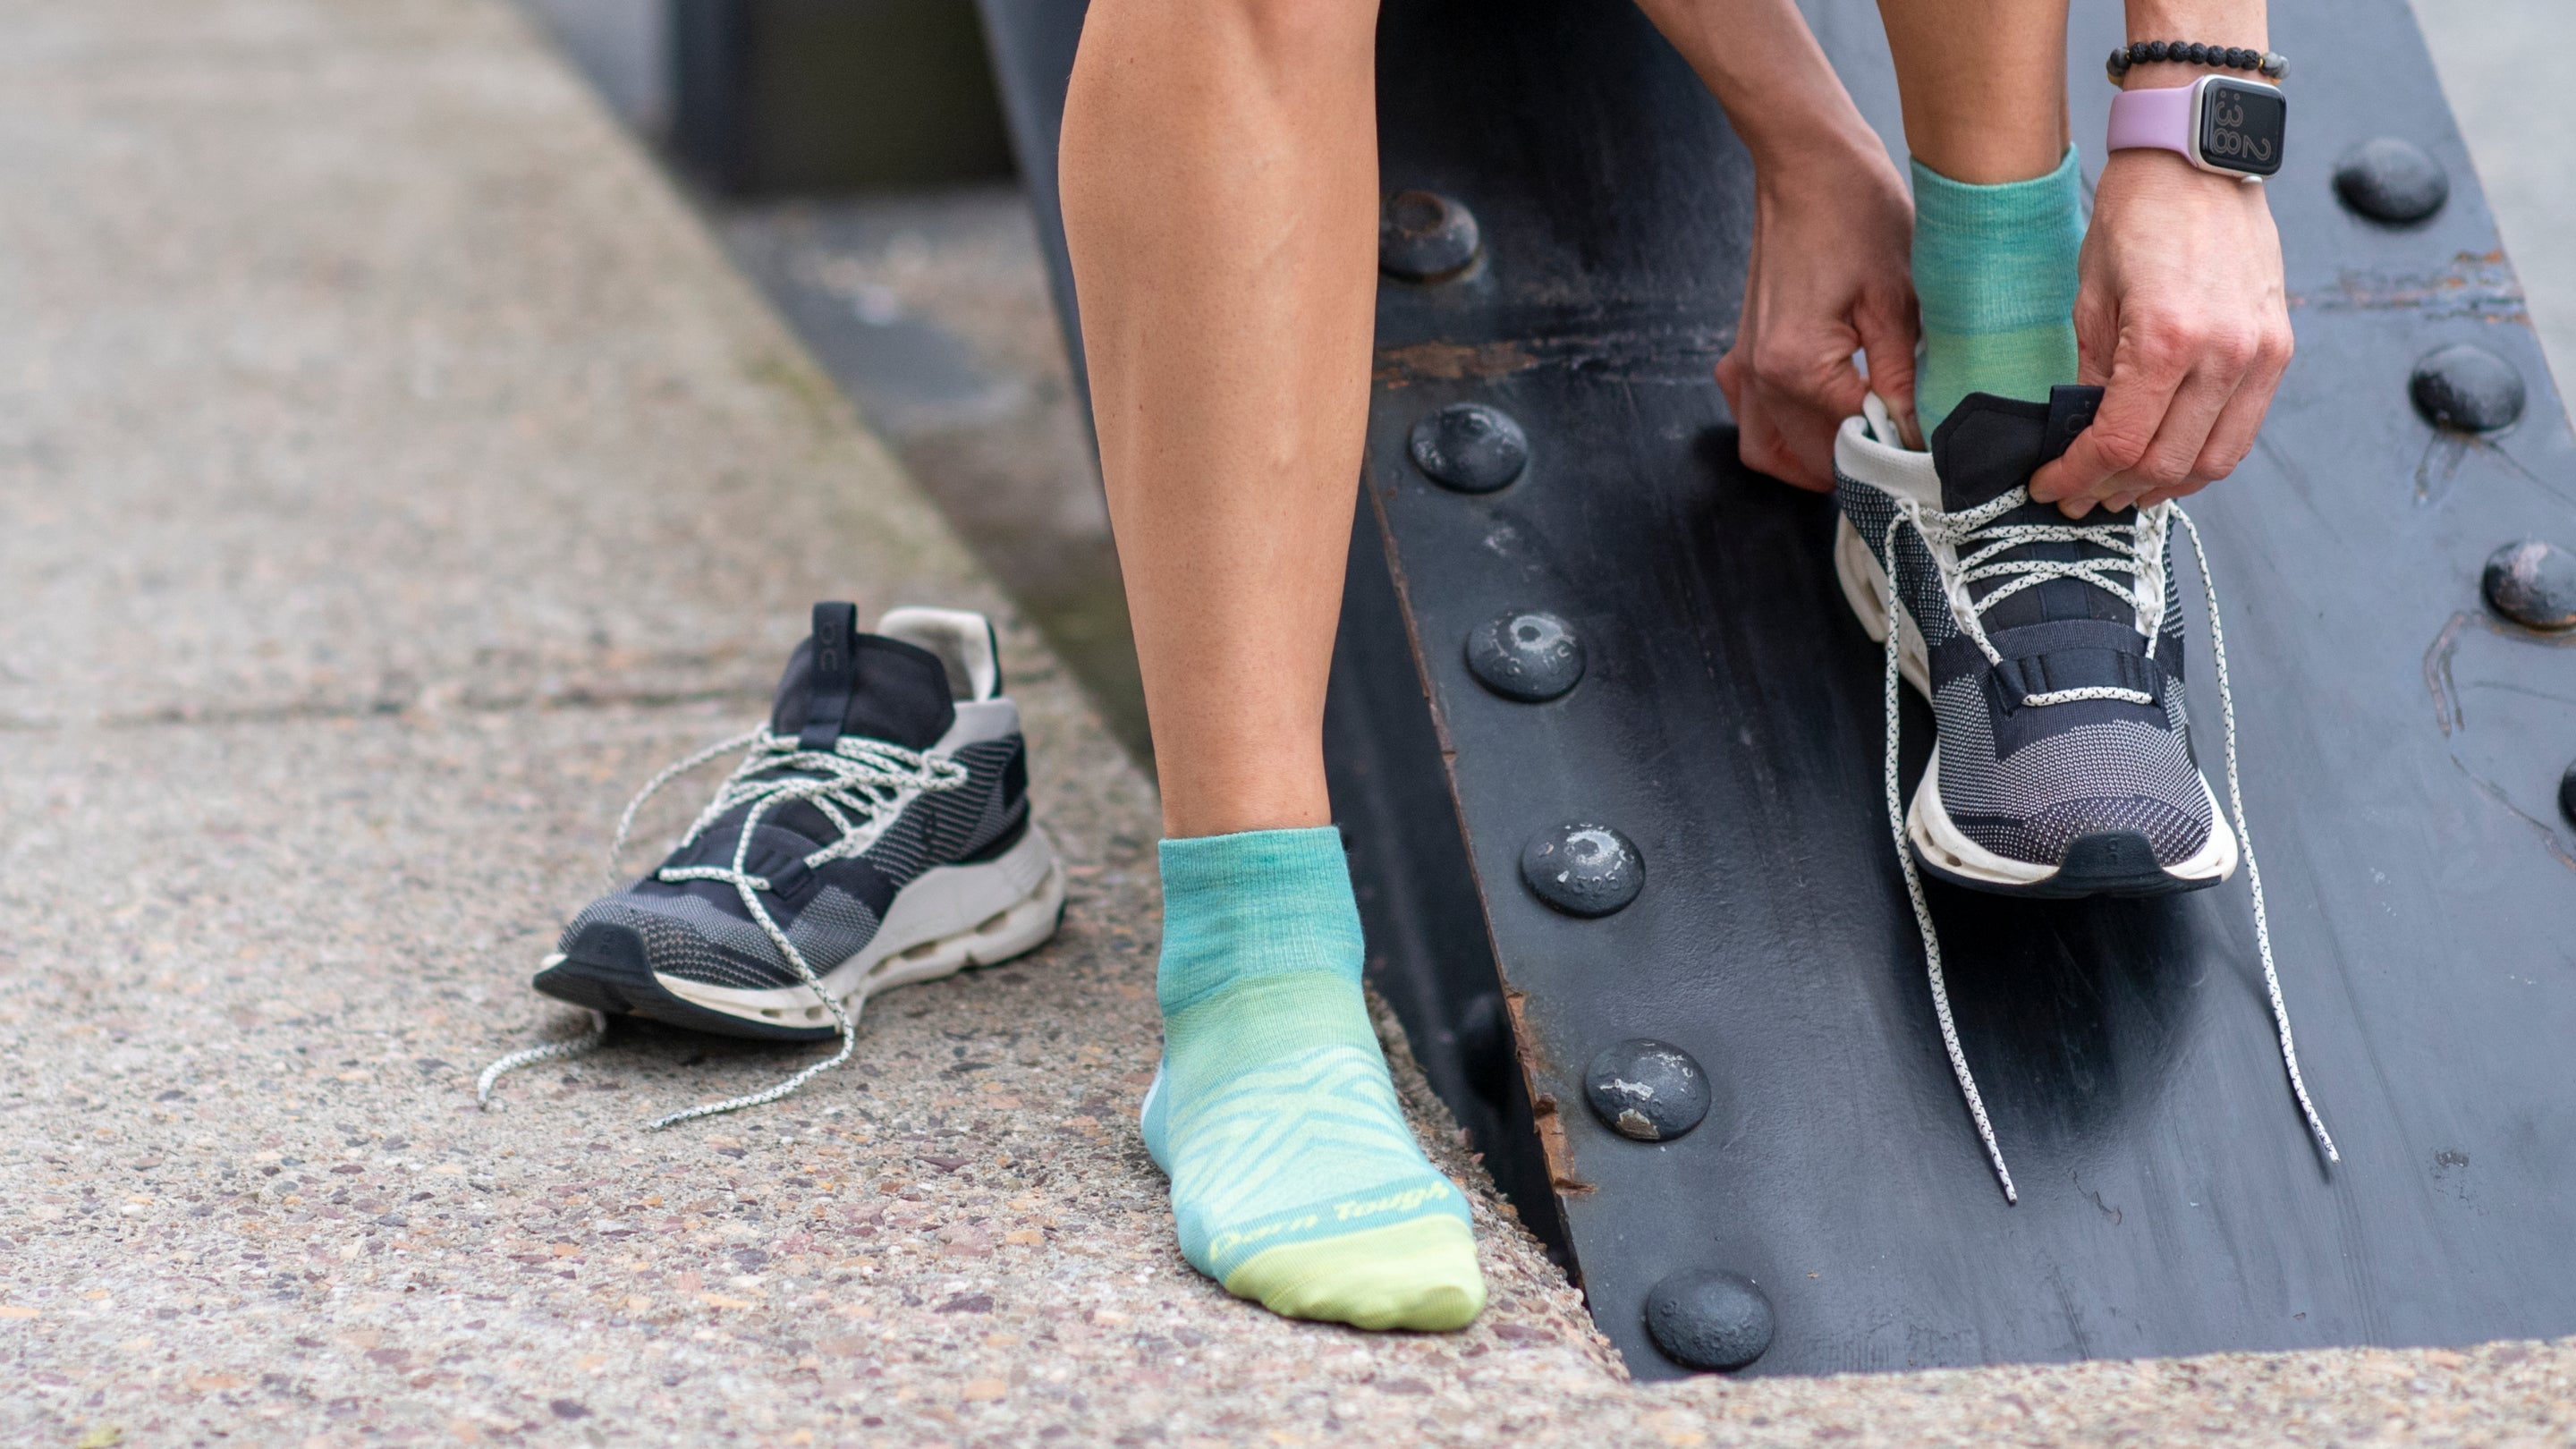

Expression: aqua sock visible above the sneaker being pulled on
xmin=1914 ymin=147 xmax=2084 ymax=438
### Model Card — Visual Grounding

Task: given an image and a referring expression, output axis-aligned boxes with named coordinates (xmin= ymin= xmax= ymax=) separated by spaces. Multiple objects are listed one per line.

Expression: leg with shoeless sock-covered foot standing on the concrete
xmin=1063 ymin=0 xmax=1484 ymax=1328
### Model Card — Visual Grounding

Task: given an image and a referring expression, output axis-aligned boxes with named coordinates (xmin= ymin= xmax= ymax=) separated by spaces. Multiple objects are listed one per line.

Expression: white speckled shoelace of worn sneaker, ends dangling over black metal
xmin=1883 ymin=487 xmax=2342 ymax=1204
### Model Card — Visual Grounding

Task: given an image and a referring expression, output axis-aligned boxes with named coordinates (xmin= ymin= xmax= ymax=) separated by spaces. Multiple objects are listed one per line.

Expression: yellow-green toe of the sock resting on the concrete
xmin=1226 ymin=1215 xmax=1484 ymax=1333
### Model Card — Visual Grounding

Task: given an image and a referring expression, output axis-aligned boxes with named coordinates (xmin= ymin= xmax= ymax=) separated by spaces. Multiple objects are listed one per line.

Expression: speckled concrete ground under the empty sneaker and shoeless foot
xmin=14 ymin=0 xmax=2576 ymax=1449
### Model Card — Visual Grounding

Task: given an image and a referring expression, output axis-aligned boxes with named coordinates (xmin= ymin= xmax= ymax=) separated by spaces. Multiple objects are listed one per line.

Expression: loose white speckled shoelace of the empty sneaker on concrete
xmin=474 ymin=724 xmax=966 ymax=1131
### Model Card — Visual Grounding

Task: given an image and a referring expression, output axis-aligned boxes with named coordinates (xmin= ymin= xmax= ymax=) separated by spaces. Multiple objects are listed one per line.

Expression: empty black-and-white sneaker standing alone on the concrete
xmin=492 ymin=604 xmax=1063 ymax=1124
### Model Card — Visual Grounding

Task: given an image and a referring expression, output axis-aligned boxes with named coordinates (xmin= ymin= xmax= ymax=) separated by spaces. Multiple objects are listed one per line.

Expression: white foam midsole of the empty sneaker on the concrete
xmin=655 ymin=823 xmax=1063 ymax=1026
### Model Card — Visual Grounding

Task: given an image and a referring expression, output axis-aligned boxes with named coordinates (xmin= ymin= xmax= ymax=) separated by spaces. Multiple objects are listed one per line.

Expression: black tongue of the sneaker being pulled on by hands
xmin=1932 ymin=386 xmax=2136 ymax=631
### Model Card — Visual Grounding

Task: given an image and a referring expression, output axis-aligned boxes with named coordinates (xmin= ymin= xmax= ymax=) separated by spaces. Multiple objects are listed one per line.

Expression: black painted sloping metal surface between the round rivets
xmin=987 ymin=0 xmax=2576 ymax=1377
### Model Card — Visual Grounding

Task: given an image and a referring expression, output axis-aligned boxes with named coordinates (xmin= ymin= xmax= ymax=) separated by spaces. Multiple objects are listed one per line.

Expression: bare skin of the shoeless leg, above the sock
xmin=1062 ymin=0 xmax=1378 ymax=835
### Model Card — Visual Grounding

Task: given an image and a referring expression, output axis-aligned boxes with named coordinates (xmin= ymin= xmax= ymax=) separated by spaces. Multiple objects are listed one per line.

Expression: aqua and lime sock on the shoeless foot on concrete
xmin=1144 ymin=827 xmax=1484 ymax=1328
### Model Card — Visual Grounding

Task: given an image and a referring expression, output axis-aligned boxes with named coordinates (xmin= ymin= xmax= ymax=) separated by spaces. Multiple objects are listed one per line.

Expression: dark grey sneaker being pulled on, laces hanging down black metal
xmin=1835 ymin=386 xmax=2334 ymax=1199
